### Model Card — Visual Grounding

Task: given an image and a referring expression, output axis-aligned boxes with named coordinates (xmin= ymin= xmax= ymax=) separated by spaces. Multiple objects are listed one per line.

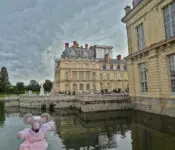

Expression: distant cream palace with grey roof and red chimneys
xmin=54 ymin=41 xmax=128 ymax=93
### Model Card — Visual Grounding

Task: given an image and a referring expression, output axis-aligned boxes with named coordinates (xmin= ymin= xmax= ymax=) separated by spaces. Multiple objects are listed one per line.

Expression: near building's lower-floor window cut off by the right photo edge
xmin=169 ymin=54 xmax=175 ymax=93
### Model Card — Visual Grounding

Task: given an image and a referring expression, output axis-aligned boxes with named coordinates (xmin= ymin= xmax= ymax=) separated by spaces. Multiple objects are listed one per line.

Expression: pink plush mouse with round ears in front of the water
xmin=18 ymin=113 xmax=56 ymax=150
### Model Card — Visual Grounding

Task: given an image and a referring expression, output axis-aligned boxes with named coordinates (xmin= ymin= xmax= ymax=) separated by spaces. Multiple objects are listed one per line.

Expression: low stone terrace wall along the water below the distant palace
xmin=5 ymin=94 xmax=131 ymax=112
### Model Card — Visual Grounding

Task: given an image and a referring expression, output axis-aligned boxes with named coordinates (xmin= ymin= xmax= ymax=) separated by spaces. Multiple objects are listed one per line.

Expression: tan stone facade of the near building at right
xmin=122 ymin=0 xmax=175 ymax=100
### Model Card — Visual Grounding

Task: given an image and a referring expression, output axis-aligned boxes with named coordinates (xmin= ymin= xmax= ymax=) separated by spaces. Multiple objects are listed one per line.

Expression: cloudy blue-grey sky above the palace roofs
xmin=0 ymin=0 xmax=132 ymax=84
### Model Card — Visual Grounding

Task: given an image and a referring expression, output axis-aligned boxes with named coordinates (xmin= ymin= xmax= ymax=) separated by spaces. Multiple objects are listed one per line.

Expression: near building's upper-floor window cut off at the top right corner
xmin=163 ymin=2 xmax=175 ymax=39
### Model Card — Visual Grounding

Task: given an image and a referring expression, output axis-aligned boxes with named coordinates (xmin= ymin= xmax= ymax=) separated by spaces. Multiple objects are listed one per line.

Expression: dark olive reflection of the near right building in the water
xmin=131 ymin=112 xmax=175 ymax=150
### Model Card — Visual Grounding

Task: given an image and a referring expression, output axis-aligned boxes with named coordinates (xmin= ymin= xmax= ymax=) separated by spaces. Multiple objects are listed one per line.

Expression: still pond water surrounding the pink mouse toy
xmin=0 ymin=104 xmax=175 ymax=150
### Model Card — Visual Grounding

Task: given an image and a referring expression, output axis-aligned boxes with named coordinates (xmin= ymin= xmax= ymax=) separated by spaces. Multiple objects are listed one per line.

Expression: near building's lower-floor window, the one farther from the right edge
xmin=139 ymin=63 xmax=148 ymax=92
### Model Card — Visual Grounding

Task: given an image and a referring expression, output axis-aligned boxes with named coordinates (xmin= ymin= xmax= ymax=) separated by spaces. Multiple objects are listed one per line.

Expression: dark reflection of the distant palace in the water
xmin=56 ymin=111 xmax=130 ymax=150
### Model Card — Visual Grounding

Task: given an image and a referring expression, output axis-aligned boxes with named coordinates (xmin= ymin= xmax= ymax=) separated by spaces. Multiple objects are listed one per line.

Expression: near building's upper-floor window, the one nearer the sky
xmin=136 ymin=23 xmax=145 ymax=50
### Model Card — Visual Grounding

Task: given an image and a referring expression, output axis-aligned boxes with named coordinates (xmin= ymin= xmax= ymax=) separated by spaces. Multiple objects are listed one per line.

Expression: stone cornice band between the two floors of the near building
xmin=124 ymin=37 xmax=175 ymax=60
